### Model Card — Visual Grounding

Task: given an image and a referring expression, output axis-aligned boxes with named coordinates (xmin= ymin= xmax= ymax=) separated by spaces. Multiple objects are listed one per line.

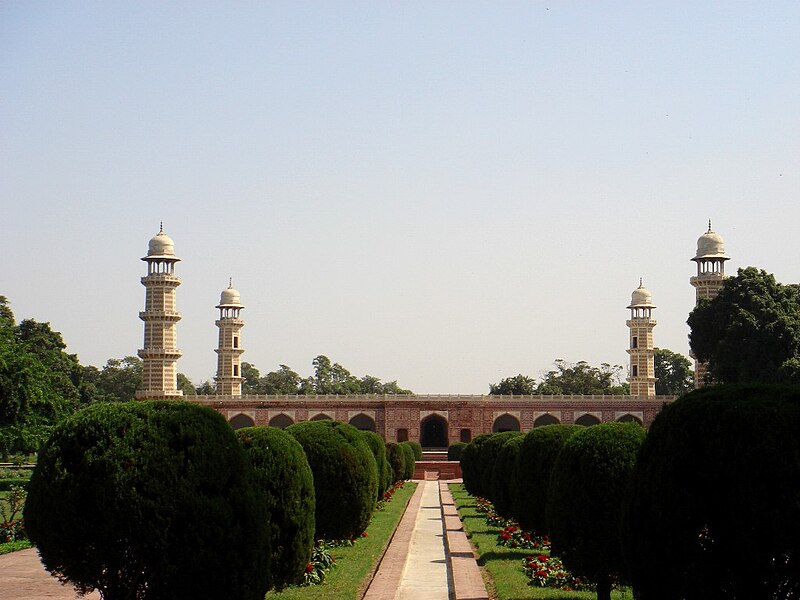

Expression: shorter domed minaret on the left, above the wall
xmin=214 ymin=281 xmax=244 ymax=396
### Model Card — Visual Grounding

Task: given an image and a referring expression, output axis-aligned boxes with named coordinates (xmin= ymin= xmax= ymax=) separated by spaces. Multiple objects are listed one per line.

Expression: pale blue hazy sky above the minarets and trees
xmin=0 ymin=0 xmax=800 ymax=394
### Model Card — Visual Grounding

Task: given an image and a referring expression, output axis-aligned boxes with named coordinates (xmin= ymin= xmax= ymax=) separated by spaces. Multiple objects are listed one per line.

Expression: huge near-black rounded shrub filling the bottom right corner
xmin=624 ymin=384 xmax=800 ymax=600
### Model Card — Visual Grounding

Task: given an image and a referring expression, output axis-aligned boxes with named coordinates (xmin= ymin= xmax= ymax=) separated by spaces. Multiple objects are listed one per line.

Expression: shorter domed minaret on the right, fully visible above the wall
xmin=626 ymin=279 xmax=656 ymax=398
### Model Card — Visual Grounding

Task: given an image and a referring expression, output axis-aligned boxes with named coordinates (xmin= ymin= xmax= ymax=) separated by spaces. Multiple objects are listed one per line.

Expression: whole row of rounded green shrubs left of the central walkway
xmin=24 ymin=401 xmax=400 ymax=600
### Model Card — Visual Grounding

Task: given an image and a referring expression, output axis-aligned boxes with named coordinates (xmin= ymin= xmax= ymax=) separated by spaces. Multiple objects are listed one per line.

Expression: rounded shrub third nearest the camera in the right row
xmin=511 ymin=425 xmax=581 ymax=535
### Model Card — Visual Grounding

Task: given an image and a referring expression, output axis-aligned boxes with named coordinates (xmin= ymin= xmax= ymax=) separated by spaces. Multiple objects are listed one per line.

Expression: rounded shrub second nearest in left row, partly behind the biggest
xmin=236 ymin=427 xmax=315 ymax=589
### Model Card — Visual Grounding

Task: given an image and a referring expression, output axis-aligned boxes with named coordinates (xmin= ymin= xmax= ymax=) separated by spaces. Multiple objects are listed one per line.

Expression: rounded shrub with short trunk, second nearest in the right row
xmin=547 ymin=423 xmax=648 ymax=600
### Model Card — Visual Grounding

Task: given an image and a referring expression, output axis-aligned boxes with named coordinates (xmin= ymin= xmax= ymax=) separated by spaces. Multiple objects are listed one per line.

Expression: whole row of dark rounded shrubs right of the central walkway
xmin=461 ymin=385 xmax=800 ymax=600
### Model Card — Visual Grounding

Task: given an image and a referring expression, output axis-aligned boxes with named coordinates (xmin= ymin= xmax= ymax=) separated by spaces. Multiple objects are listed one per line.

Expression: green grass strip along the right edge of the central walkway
xmin=450 ymin=483 xmax=633 ymax=600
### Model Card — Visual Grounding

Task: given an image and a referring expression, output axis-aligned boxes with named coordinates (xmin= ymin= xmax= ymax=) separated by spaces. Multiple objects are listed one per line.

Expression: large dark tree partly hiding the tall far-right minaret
xmin=687 ymin=267 xmax=800 ymax=383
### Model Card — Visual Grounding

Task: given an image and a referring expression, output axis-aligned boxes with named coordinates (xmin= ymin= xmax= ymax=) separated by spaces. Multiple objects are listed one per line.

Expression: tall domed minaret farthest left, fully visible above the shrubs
xmin=136 ymin=224 xmax=183 ymax=399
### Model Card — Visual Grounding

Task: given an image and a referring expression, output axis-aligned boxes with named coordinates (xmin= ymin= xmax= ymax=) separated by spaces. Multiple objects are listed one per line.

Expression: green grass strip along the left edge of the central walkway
xmin=266 ymin=481 xmax=417 ymax=600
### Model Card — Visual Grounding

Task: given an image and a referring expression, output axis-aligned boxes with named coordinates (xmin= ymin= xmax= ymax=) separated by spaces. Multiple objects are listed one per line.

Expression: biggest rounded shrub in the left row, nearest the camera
xmin=24 ymin=401 xmax=271 ymax=600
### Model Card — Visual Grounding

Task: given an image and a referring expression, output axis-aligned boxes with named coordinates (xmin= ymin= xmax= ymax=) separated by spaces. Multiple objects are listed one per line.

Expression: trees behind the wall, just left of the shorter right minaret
xmin=536 ymin=358 xmax=629 ymax=395
